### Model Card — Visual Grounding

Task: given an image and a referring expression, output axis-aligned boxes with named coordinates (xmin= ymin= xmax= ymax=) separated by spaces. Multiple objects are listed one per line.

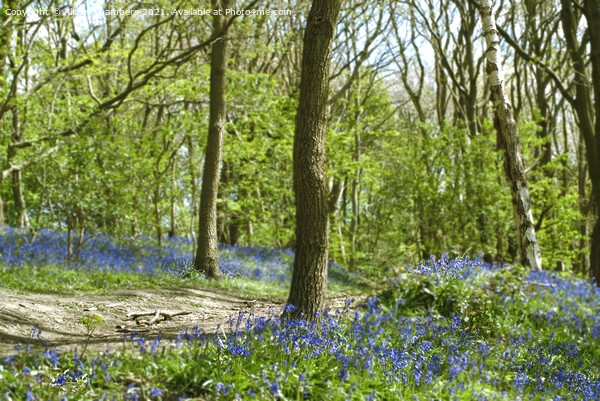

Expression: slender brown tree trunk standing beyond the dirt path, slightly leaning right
xmin=194 ymin=0 xmax=232 ymax=279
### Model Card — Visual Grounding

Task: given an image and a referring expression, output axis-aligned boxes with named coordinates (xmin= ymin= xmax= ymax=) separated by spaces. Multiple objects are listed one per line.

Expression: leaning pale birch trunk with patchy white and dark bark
xmin=481 ymin=0 xmax=542 ymax=269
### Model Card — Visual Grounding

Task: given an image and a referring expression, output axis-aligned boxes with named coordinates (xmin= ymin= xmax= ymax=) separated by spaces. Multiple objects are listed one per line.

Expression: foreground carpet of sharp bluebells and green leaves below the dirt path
xmin=0 ymin=228 xmax=600 ymax=400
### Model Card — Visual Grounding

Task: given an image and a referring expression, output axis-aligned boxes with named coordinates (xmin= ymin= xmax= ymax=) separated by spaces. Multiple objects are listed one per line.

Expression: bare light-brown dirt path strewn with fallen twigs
xmin=0 ymin=288 xmax=354 ymax=356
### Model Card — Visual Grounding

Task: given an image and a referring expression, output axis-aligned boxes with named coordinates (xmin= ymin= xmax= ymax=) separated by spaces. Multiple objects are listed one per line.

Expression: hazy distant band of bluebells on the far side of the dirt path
xmin=0 ymin=227 xmax=358 ymax=286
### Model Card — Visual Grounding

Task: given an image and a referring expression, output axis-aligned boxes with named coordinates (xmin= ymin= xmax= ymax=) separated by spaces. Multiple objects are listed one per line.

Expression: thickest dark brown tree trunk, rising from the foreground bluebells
xmin=288 ymin=0 xmax=340 ymax=319
